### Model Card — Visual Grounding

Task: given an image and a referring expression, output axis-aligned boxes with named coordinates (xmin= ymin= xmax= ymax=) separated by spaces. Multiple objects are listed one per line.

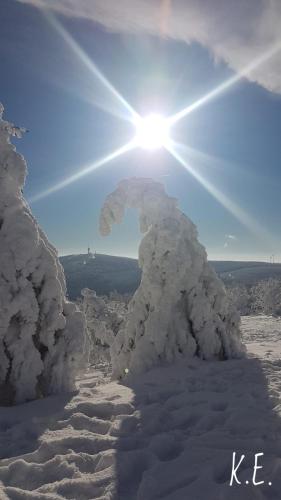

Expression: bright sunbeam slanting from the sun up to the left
xmin=37 ymin=2 xmax=138 ymax=121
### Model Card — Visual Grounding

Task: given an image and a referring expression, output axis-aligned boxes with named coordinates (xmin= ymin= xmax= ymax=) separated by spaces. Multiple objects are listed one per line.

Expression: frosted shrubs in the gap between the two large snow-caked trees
xmin=81 ymin=288 xmax=127 ymax=363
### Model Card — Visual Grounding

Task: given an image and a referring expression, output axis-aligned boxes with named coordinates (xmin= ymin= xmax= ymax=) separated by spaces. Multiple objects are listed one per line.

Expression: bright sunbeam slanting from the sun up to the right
xmin=169 ymin=42 xmax=281 ymax=125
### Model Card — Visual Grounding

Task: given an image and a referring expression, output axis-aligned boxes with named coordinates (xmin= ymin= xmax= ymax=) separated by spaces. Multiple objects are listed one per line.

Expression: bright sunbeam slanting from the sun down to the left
xmin=28 ymin=140 xmax=136 ymax=205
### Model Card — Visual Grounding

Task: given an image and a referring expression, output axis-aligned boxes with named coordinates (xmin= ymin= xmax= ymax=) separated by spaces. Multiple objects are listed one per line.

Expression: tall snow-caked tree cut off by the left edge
xmin=0 ymin=105 xmax=86 ymax=404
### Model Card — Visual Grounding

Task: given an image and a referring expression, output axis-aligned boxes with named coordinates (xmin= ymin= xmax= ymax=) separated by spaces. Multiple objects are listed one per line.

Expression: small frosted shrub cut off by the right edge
xmin=251 ymin=278 xmax=281 ymax=316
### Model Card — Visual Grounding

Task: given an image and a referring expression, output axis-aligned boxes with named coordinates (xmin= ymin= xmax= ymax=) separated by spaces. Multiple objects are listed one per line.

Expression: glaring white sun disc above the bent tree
xmin=135 ymin=113 xmax=170 ymax=150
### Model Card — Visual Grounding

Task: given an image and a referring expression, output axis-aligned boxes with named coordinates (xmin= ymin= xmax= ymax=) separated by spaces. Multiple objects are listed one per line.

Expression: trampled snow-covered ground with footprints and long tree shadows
xmin=0 ymin=316 xmax=281 ymax=500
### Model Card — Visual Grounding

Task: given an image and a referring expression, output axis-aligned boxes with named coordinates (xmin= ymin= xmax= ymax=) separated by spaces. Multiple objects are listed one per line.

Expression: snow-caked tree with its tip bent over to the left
xmin=100 ymin=179 xmax=244 ymax=377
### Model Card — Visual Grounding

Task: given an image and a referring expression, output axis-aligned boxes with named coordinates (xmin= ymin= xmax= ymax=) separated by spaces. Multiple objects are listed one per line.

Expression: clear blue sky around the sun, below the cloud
xmin=0 ymin=0 xmax=281 ymax=261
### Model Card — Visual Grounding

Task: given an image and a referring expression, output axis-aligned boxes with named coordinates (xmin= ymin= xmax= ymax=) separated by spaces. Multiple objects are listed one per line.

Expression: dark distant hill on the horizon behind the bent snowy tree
xmin=60 ymin=254 xmax=281 ymax=300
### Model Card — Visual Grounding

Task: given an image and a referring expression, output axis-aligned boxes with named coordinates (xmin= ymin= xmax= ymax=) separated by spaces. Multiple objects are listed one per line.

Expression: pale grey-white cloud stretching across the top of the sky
xmin=18 ymin=0 xmax=281 ymax=93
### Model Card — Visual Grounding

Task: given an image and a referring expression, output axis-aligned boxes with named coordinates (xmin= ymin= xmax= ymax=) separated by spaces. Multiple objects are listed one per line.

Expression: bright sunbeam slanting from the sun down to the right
xmin=166 ymin=142 xmax=273 ymax=242
